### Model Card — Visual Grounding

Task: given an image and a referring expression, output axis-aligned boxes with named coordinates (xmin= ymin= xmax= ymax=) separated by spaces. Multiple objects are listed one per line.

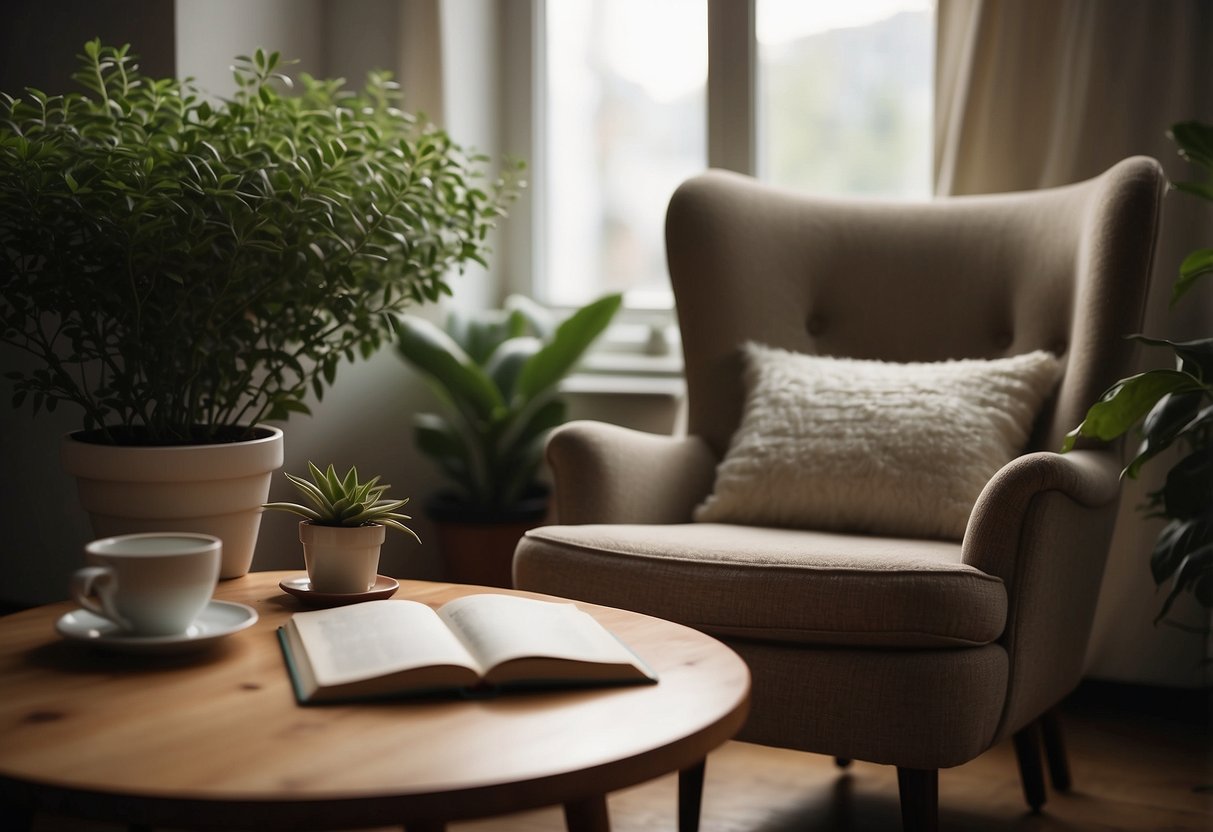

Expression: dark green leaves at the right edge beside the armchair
xmin=1061 ymin=121 xmax=1213 ymax=628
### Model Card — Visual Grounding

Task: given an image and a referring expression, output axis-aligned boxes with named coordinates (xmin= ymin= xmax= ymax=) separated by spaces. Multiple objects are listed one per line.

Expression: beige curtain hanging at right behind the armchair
xmin=934 ymin=0 xmax=1213 ymax=686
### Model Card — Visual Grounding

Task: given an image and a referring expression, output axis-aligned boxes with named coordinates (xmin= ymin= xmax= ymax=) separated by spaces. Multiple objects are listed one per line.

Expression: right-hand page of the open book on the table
xmin=438 ymin=594 xmax=636 ymax=668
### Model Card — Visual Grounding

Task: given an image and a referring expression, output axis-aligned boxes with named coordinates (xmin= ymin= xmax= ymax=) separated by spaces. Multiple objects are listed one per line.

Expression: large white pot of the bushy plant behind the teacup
xmin=61 ymin=426 xmax=283 ymax=579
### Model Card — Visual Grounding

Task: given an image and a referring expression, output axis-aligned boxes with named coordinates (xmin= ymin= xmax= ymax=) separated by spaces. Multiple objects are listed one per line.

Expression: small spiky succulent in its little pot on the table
xmin=263 ymin=462 xmax=421 ymax=594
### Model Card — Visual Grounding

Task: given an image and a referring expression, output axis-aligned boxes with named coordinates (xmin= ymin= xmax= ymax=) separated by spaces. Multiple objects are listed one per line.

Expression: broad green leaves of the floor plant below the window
xmin=398 ymin=295 xmax=622 ymax=513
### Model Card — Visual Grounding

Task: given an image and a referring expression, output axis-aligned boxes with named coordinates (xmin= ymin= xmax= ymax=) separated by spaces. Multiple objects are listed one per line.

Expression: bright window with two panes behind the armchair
xmin=528 ymin=0 xmax=934 ymax=310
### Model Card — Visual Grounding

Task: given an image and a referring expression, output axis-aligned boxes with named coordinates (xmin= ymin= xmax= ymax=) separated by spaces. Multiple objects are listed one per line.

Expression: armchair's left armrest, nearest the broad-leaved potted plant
xmin=547 ymin=421 xmax=717 ymax=524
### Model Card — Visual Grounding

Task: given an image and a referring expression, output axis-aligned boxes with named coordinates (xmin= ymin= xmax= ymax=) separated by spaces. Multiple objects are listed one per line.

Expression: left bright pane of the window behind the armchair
xmin=536 ymin=0 xmax=707 ymax=308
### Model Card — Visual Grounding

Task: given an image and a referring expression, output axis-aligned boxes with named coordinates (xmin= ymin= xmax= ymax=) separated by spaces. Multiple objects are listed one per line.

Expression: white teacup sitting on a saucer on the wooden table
xmin=72 ymin=531 xmax=222 ymax=636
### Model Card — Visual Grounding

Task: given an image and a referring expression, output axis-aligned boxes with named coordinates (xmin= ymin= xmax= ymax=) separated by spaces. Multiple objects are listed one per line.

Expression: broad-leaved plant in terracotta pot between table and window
xmin=398 ymin=295 xmax=622 ymax=587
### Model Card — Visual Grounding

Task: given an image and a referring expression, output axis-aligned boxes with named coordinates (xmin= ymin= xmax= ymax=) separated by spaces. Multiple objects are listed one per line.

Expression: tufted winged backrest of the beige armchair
xmin=666 ymin=156 xmax=1164 ymax=455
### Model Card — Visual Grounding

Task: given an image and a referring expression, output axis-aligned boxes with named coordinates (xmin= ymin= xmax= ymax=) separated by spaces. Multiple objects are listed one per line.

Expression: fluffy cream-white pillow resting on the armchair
xmin=695 ymin=343 xmax=1061 ymax=540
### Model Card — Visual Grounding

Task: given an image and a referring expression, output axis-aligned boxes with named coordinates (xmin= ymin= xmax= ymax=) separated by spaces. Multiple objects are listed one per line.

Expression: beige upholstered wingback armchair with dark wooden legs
xmin=514 ymin=158 xmax=1164 ymax=830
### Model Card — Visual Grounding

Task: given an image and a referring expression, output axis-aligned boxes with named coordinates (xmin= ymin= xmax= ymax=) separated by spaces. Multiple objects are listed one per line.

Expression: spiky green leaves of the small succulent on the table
xmin=262 ymin=462 xmax=421 ymax=543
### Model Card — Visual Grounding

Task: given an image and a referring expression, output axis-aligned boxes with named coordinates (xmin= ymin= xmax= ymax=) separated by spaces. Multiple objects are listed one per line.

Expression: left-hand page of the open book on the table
xmin=292 ymin=600 xmax=480 ymax=686
